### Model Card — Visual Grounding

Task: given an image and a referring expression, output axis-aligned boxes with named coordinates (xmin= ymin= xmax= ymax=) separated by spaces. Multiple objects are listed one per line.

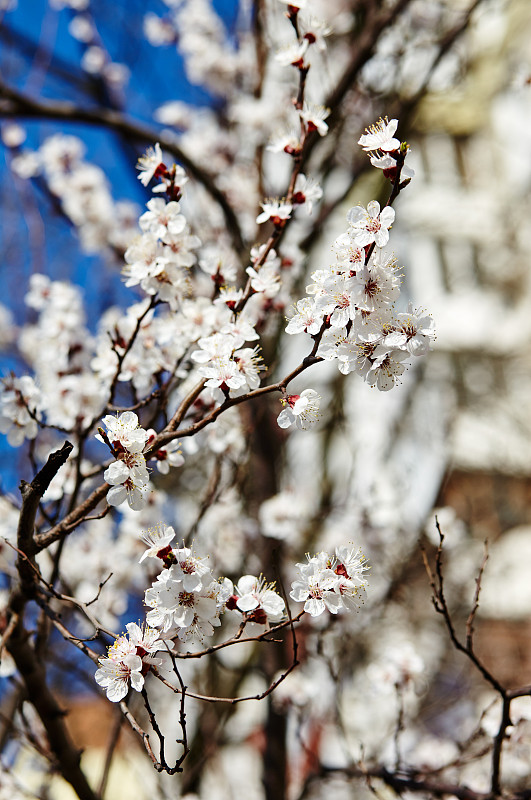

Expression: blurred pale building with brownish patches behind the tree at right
xmin=399 ymin=0 xmax=531 ymax=685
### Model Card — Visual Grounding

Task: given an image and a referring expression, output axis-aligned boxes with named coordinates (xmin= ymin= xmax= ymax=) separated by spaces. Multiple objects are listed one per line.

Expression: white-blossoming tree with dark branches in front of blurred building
xmin=0 ymin=0 xmax=525 ymax=800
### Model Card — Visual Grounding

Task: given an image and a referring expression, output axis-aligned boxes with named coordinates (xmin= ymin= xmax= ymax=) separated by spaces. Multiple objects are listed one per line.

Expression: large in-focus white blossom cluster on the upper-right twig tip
xmin=286 ymin=120 xmax=434 ymax=390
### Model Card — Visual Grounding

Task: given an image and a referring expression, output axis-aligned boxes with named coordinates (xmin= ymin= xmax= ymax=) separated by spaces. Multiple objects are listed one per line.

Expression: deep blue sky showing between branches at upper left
xmin=0 ymin=0 xmax=238 ymax=491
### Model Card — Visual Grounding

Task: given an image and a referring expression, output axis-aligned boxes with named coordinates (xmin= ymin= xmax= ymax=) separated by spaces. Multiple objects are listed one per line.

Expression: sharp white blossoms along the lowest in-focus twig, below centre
xmin=96 ymin=524 xmax=368 ymax=702
